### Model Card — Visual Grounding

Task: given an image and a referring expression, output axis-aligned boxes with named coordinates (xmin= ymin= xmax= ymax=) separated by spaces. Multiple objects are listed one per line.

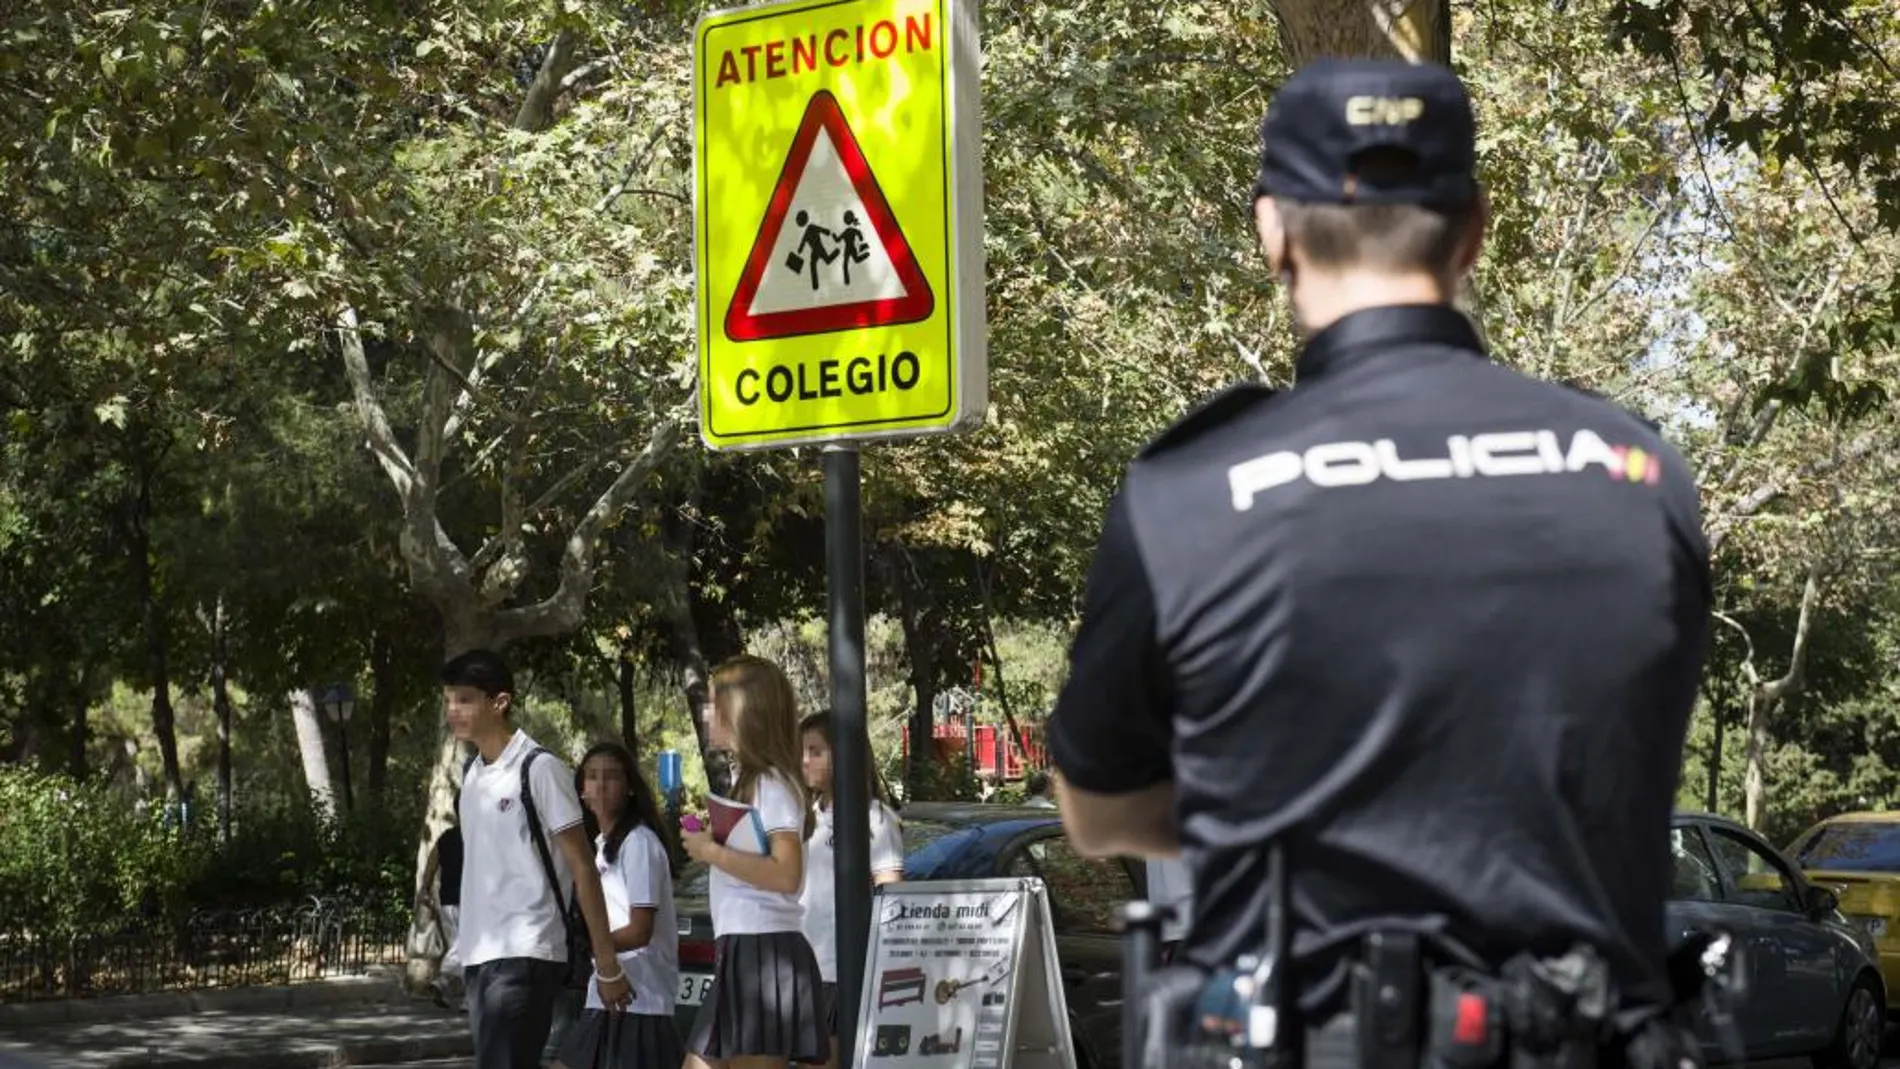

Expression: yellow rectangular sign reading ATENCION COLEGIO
xmin=694 ymin=0 xmax=988 ymax=448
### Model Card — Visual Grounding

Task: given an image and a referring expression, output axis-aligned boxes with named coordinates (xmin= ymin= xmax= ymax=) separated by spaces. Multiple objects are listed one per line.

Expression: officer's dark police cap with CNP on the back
xmin=1254 ymin=59 xmax=1478 ymax=205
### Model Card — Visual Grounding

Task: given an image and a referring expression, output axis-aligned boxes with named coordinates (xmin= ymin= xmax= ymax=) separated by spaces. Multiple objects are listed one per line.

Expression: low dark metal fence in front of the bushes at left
xmin=0 ymin=898 xmax=409 ymax=1003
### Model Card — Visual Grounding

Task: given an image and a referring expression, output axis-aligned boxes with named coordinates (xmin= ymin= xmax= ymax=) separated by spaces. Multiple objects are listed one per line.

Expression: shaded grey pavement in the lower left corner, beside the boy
xmin=0 ymin=980 xmax=471 ymax=1069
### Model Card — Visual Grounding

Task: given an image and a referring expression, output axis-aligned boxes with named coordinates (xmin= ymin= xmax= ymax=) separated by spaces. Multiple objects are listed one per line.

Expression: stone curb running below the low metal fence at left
xmin=0 ymin=966 xmax=407 ymax=1031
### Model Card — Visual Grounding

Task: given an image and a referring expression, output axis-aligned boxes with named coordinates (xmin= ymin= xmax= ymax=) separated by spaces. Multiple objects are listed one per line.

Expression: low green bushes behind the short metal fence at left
xmin=0 ymin=769 xmax=420 ymax=934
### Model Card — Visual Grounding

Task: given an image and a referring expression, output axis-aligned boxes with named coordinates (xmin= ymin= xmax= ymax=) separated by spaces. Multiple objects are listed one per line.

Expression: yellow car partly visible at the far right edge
xmin=1788 ymin=811 xmax=1900 ymax=1006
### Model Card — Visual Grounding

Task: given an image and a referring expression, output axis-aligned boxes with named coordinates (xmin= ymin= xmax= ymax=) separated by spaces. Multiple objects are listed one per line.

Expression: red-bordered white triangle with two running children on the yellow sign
xmin=726 ymin=89 xmax=937 ymax=342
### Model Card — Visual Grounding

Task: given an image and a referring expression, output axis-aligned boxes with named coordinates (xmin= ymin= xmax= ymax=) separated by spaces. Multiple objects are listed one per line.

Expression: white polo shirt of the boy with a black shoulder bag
xmin=456 ymin=729 xmax=581 ymax=966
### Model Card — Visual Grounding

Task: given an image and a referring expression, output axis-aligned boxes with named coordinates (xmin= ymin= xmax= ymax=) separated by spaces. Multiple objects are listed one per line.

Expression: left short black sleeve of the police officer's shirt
xmin=1049 ymin=494 xmax=1174 ymax=794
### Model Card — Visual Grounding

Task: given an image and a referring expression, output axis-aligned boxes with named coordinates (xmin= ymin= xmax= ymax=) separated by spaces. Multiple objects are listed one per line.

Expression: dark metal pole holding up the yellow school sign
xmin=825 ymin=444 xmax=870 ymax=1069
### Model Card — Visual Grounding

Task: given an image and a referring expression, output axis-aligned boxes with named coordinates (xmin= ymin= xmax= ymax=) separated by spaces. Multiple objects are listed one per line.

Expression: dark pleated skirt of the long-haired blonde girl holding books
xmin=686 ymin=932 xmax=830 ymax=1065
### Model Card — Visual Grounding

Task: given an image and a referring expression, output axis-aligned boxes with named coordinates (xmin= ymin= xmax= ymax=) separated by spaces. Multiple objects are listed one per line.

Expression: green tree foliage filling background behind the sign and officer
xmin=0 ymin=0 xmax=1900 ymax=896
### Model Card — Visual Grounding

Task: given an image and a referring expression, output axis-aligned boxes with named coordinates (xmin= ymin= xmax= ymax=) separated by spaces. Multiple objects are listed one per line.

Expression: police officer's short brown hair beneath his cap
xmin=1275 ymin=150 xmax=1478 ymax=272
